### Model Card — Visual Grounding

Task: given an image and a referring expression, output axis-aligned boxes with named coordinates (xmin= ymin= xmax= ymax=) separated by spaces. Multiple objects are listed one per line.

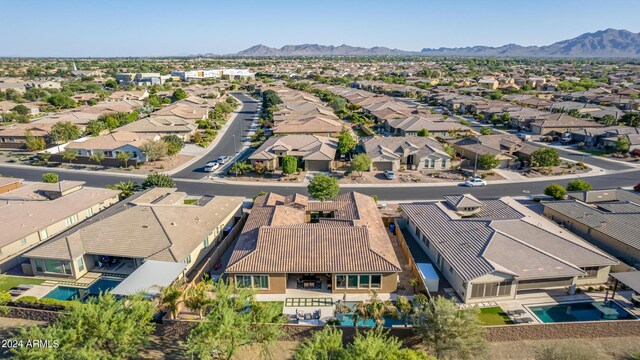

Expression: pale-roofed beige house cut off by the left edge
xmin=0 ymin=178 xmax=120 ymax=272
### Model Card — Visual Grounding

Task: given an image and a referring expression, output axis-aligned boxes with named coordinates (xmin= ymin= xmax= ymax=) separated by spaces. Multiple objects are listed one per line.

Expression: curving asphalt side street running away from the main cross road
xmin=173 ymin=92 xmax=260 ymax=179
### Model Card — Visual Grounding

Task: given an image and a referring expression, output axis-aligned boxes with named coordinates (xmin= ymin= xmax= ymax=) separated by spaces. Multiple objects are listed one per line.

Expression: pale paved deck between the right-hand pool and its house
xmin=498 ymin=289 xmax=640 ymax=323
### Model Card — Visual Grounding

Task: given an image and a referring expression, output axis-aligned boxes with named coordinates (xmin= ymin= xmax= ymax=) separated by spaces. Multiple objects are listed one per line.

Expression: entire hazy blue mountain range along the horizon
xmin=234 ymin=29 xmax=640 ymax=58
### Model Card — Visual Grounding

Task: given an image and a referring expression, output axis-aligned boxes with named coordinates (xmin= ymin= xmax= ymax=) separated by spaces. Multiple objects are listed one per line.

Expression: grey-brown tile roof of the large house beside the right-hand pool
xmin=400 ymin=198 xmax=617 ymax=281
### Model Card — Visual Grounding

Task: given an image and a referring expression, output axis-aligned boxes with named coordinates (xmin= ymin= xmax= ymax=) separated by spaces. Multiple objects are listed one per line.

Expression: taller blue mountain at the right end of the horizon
xmin=420 ymin=29 xmax=640 ymax=58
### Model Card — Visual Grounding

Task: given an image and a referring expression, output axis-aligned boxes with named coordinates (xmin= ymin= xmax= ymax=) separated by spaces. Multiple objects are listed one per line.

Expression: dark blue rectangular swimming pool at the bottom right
xmin=529 ymin=301 xmax=633 ymax=323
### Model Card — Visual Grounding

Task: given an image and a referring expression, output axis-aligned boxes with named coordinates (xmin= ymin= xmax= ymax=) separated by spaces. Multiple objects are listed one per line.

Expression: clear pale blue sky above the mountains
xmin=5 ymin=0 xmax=640 ymax=57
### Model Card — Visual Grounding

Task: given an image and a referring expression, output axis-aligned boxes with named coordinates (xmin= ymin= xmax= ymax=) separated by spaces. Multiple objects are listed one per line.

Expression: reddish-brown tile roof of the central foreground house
xmin=226 ymin=192 xmax=401 ymax=273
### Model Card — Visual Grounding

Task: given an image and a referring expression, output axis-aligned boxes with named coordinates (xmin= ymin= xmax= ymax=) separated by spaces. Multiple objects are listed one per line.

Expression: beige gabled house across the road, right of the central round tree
xmin=361 ymin=137 xmax=451 ymax=171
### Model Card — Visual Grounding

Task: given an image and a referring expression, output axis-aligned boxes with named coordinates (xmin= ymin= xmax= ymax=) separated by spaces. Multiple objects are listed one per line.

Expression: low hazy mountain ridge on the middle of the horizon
xmin=236 ymin=44 xmax=418 ymax=56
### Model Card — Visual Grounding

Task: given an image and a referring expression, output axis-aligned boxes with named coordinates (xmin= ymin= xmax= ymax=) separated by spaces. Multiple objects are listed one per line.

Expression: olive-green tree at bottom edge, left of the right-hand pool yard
xmin=413 ymin=296 xmax=487 ymax=359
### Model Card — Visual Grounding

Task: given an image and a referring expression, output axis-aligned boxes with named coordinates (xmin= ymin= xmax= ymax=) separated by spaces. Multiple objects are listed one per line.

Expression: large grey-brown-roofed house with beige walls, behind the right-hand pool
xmin=399 ymin=194 xmax=618 ymax=303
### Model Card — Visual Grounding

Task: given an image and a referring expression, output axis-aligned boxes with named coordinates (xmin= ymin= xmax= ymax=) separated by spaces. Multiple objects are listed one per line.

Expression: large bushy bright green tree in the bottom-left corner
xmin=11 ymin=294 xmax=155 ymax=359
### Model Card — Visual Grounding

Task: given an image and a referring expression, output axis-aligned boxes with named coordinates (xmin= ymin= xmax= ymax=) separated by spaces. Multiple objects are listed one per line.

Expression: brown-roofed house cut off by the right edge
xmin=543 ymin=189 xmax=640 ymax=267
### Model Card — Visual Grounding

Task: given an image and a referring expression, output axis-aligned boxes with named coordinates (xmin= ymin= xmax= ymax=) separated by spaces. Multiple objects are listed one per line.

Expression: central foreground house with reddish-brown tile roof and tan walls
xmin=225 ymin=192 xmax=402 ymax=295
